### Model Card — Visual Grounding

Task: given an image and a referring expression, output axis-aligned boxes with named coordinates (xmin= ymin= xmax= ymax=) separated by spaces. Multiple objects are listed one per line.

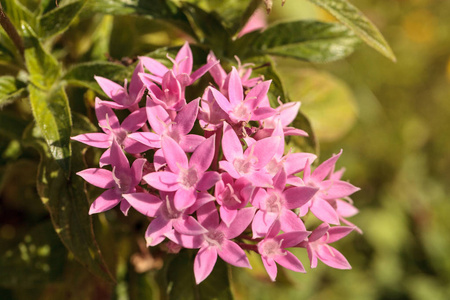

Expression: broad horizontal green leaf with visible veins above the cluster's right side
xmin=243 ymin=21 xmax=359 ymax=63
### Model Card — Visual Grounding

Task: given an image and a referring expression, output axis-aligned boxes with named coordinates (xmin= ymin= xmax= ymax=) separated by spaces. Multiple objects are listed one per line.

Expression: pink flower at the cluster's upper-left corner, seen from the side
xmin=94 ymin=62 xmax=145 ymax=111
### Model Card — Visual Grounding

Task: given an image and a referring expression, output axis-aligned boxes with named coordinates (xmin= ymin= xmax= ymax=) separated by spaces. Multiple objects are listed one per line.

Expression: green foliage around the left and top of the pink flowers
xmin=0 ymin=0 xmax=400 ymax=299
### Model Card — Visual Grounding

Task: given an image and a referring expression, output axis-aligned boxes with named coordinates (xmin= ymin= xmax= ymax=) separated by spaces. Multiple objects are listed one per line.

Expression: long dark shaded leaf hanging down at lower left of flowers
xmin=23 ymin=115 xmax=114 ymax=282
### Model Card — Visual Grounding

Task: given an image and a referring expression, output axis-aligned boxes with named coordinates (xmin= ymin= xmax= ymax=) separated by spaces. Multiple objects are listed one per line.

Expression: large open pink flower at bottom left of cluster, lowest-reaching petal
xmin=166 ymin=202 xmax=255 ymax=284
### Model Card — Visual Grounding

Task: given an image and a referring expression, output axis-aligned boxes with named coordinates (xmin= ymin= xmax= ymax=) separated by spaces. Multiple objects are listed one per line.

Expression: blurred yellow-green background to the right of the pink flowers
xmin=230 ymin=0 xmax=450 ymax=300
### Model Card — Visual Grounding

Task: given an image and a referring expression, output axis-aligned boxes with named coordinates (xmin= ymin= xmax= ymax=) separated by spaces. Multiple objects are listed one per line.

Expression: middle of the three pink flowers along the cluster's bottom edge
xmin=258 ymin=221 xmax=310 ymax=281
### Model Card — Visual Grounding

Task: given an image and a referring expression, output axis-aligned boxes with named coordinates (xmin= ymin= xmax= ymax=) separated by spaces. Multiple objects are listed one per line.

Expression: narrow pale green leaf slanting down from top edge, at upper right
xmin=309 ymin=0 xmax=397 ymax=61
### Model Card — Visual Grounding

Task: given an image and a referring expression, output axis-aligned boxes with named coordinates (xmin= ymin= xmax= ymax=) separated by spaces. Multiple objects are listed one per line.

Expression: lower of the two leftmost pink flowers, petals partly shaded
xmin=77 ymin=141 xmax=146 ymax=215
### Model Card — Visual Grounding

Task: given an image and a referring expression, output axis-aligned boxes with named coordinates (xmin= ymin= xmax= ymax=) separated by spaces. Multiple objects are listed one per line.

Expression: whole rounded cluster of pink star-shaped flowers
xmin=72 ymin=43 xmax=359 ymax=283
